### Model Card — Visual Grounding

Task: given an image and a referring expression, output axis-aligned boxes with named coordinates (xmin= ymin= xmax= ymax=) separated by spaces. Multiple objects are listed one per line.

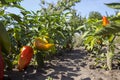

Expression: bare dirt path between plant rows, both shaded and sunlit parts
xmin=6 ymin=49 xmax=120 ymax=80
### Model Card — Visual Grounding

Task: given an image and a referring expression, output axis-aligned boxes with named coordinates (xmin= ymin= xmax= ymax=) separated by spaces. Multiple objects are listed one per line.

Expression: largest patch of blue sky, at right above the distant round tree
xmin=74 ymin=0 xmax=120 ymax=16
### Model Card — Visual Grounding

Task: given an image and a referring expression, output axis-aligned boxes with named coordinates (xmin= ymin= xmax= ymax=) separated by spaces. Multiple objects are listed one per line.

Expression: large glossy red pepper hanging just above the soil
xmin=18 ymin=46 xmax=34 ymax=71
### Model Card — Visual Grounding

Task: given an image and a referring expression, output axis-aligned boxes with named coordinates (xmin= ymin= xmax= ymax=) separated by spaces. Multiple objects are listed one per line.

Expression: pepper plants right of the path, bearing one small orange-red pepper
xmin=82 ymin=3 xmax=120 ymax=70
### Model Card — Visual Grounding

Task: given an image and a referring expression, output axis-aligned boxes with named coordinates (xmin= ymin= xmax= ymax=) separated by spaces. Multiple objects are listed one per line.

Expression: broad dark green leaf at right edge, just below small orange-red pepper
xmin=95 ymin=23 xmax=120 ymax=36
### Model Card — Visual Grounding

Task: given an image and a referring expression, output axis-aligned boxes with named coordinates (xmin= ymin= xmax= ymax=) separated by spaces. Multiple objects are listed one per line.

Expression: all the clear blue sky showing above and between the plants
xmin=8 ymin=0 xmax=120 ymax=17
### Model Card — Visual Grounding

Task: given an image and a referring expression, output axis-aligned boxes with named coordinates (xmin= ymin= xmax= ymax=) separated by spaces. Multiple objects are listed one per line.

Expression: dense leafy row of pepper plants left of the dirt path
xmin=0 ymin=0 xmax=82 ymax=80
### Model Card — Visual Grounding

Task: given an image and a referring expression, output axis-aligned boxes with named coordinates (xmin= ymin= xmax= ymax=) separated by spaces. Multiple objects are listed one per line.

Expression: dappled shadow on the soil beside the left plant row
xmin=5 ymin=49 xmax=90 ymax=80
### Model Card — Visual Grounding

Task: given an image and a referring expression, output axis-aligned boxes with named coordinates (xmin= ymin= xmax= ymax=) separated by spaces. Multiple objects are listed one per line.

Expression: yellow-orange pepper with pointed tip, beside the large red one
xmin=34 ymin=38 xmax=54 ymax=51
